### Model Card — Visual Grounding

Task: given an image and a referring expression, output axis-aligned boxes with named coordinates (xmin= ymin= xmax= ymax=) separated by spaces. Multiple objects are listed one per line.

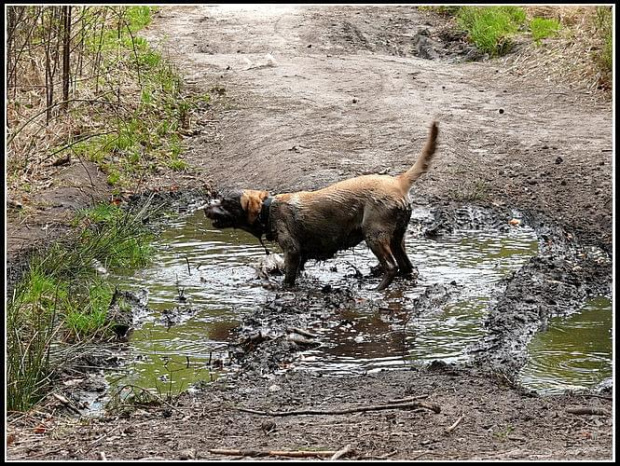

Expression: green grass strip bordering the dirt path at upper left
xmin=56 ymin=6 xmax=210 ymax=189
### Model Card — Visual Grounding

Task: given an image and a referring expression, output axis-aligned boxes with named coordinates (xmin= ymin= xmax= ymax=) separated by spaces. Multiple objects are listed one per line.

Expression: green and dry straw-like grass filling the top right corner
xmin=420 ymin=5 xmax=613 ymax=94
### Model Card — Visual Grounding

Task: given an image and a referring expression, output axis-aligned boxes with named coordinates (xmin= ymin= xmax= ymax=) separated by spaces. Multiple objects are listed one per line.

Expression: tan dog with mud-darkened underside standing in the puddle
xmin=204 ymin=122 xmax=439 ymax=290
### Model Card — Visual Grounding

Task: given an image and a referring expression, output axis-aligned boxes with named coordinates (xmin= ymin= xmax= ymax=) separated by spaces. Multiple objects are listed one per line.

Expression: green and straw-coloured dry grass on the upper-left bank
xmin=7 ymin=6 xmax=210 ymax=197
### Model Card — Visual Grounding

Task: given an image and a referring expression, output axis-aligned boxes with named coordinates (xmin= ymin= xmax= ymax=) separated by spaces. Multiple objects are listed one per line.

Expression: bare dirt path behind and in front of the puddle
xmin=4 ymin=5 xmax=613 ymax=460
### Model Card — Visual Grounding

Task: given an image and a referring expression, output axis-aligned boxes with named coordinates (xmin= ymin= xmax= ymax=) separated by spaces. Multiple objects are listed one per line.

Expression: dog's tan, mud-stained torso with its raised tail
xmin=272 ymin=122 xmax=438 ymax=270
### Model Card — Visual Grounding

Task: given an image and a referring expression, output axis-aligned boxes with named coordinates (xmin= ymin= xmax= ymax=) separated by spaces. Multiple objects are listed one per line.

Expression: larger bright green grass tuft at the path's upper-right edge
xmin=456 ymin=6 xmax=525 ymax=56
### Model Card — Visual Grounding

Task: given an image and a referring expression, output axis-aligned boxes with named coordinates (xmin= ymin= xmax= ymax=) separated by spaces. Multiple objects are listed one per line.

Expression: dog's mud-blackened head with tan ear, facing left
xmin=205 ymin=189 xmax=269 ymax=238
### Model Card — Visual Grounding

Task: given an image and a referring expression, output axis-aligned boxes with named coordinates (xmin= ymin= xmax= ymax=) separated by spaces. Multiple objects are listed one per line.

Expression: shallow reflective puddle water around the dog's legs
xmin=110 ymin=210 xmax=610 ymax=394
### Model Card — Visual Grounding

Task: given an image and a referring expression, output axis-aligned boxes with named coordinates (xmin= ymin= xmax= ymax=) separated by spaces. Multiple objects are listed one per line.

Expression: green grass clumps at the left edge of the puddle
xmin=6 ymin=201 xmax=153 ymax=411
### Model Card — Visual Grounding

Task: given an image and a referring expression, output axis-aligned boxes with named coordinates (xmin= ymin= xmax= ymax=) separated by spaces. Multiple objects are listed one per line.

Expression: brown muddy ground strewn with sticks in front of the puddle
xmin=9 ymin=350 xmax=613 ymax=461
